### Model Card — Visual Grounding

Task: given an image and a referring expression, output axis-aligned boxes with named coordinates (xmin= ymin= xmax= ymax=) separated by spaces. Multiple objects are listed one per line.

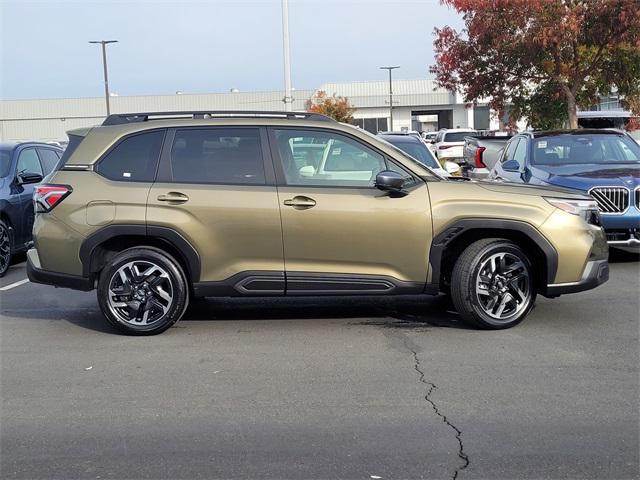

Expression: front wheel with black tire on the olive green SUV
xmin=451 ymin=238 xmax=536 ymax=330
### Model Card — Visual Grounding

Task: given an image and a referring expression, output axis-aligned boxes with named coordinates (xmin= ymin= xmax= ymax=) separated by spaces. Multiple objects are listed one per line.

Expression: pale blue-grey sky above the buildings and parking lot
xmin=0 ymin=0 xmax=462 ymax=99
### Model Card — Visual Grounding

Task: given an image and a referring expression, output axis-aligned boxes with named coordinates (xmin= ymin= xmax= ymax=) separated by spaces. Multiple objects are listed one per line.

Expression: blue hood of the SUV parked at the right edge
xmin=531 ymin=163 xmax=640 ymax=191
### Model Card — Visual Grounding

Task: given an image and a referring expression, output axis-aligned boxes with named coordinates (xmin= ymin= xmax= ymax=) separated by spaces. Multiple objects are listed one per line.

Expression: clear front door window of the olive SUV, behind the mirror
xmin=275 ymin=129 xmax=387 ymax=187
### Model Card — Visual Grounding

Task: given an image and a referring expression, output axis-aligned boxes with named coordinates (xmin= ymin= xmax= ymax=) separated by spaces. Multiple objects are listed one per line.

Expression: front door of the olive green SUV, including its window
xmin=270 ymin=128 xmax=432 ymax=295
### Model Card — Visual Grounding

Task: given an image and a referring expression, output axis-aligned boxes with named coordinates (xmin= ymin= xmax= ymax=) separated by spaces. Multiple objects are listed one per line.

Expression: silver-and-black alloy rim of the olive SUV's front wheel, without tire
xmin=476 ymin=252 xmax=532 ymax=322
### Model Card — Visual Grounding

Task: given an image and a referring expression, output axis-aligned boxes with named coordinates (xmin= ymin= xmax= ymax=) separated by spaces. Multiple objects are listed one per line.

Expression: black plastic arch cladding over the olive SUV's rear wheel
xmin=80 ymin=225 xmax=200 ymax=284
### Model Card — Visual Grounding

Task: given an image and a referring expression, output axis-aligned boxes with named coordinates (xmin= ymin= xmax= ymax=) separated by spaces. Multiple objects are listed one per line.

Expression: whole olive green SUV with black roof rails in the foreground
xmin=28 ymin=112 xmax=609 ymax=335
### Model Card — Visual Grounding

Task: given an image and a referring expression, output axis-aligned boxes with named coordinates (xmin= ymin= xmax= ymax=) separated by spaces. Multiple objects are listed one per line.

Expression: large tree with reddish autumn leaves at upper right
xmin=431 ymin=0 xmax=640 ymax=128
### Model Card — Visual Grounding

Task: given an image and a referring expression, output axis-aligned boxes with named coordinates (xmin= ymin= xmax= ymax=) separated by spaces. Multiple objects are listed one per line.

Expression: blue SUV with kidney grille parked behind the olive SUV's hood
xmin=489 ymin=129 xmax=640 ymax=251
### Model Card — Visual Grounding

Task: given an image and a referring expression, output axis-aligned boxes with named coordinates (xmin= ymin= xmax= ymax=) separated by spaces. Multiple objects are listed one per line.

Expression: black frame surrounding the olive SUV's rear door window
xmin=155 ymin=125 xmax=276 ymax=188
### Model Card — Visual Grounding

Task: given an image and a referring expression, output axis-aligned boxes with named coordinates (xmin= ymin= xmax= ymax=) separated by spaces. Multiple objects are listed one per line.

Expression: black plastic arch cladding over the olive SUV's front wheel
xmin=429 ymin=218 xmax=558 ymax=293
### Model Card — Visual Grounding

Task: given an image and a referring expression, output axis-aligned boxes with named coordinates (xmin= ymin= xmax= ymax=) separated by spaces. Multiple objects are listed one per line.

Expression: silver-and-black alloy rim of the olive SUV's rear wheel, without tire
xmin=108 ymin=260 xmax=174 ymax=327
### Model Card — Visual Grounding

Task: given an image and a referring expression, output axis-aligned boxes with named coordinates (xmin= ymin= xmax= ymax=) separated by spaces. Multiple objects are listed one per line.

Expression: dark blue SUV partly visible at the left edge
xmin=0 ymin=142 xmax=63 ymax=277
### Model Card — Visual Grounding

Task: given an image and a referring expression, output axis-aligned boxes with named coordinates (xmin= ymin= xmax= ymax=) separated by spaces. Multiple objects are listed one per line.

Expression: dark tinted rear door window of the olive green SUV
xmin=171 ymin=128 xmax=266 ymax=185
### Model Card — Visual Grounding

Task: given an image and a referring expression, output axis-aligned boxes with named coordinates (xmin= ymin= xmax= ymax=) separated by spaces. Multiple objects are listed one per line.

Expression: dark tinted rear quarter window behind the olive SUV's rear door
xmin=96 ymin=130 xmax=165 ymax=182
